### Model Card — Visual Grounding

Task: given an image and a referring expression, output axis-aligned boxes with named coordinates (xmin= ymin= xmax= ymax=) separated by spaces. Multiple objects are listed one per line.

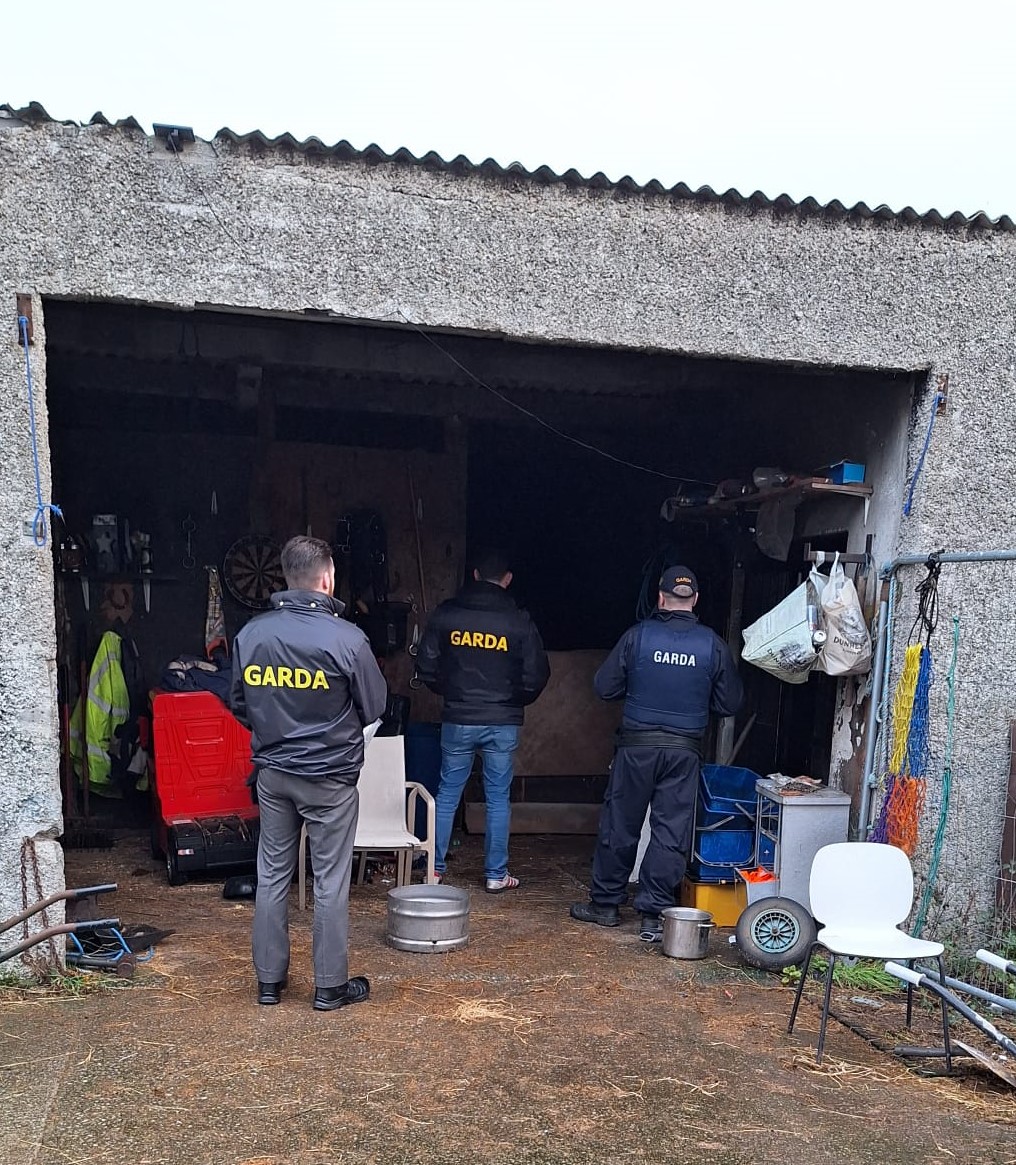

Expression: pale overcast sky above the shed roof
xmin=0 ymin=0 xmax=1016 ymax=217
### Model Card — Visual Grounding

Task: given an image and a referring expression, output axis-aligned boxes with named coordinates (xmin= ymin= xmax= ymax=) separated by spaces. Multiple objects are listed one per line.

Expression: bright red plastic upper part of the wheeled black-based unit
xmin=151 ymin=692 xmax=257 ymax=825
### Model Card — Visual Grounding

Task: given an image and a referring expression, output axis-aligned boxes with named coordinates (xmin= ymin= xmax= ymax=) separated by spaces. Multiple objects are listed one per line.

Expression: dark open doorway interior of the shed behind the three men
xmin=44 ymin=301 xmax=920 ymax=832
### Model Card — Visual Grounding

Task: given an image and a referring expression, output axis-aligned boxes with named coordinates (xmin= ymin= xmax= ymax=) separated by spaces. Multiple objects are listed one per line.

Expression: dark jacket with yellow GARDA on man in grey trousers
xmin=230 ymin=591 xmax=388 ymax=785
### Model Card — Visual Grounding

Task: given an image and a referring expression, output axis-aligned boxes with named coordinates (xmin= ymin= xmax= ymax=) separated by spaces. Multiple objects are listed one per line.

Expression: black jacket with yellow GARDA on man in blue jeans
xmin=416 ymin=583 xmax=550 ymax=725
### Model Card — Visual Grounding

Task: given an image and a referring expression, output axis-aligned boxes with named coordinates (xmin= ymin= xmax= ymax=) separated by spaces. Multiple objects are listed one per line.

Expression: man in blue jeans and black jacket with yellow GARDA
xmin=416 ymin=551 xmax=550 ymax=894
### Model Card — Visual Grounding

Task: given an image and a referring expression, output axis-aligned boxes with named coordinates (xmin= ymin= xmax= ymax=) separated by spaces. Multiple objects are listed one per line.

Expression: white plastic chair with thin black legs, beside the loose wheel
xmin=786 ymin=841 xmax=952 ymax=1069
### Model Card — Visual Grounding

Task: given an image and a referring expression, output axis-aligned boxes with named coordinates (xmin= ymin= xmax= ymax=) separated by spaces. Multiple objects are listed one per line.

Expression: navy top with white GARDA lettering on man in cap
xmin=593 ymin=610 xmax=745 ymax=737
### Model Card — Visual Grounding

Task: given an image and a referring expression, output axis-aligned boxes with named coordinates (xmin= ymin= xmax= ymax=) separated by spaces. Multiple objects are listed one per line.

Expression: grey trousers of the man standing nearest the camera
xmin=252 ymin=769 xmax=360 ymax=987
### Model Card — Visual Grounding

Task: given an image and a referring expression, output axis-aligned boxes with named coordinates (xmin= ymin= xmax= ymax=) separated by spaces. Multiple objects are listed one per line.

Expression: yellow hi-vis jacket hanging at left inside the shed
xmin=70 ymin=631 xmax=130 ymax=797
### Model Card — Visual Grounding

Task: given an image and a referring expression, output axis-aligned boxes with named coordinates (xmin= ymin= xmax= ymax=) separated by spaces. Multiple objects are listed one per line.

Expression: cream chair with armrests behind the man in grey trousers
xmin=297 ymin=736 xmax=437 ymax=910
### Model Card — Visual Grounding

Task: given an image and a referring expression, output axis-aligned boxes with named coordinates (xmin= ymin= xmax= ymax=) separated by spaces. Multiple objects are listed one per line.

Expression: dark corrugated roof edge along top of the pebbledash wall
xmin=0 ymin=101 xmax=1016 ymax=232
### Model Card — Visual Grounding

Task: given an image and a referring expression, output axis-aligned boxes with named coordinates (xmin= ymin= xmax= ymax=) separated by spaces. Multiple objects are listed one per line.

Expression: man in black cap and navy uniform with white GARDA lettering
xmin=571 ymin=566 xmax=743 ymax=942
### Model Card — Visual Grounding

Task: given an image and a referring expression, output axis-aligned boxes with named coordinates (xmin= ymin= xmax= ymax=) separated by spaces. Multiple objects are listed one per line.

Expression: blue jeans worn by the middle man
xmin=435 ymin=725 xmax=518 ymax=878
